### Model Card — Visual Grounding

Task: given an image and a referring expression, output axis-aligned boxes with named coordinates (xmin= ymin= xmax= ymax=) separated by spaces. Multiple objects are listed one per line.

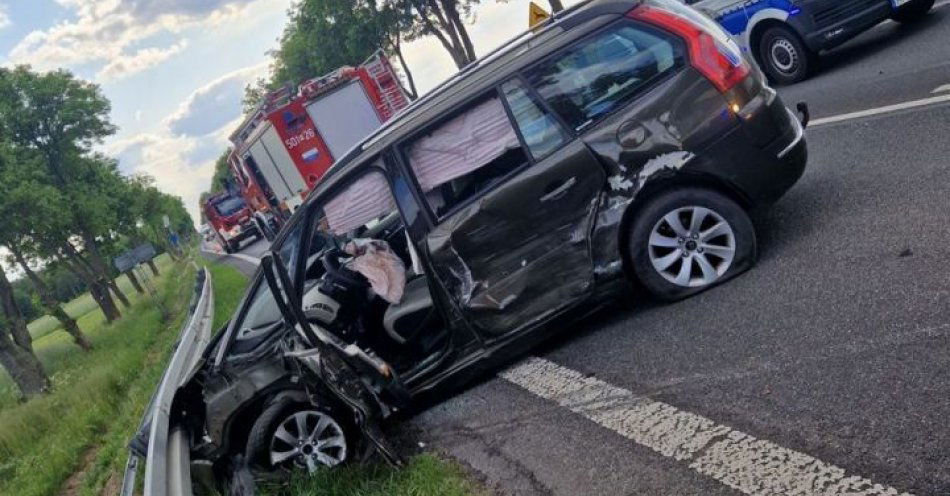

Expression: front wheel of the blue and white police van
xmin=758 ymin=26 xmax=818 ymax=84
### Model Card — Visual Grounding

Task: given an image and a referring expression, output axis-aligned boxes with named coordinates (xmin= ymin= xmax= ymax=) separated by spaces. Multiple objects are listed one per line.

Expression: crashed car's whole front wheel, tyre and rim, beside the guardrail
xmin=245 ymin=398 xmax=353 ymax=474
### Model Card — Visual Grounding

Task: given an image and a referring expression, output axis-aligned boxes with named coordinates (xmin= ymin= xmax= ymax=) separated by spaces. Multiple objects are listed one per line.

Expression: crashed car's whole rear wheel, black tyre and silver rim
xmin=628 ymin=188 xmax=756 ymax=301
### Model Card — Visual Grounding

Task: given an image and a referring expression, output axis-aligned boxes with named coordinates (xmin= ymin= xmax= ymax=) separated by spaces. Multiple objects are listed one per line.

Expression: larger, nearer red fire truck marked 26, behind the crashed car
xmin=229 ymin=53 xmax=409 ymax=237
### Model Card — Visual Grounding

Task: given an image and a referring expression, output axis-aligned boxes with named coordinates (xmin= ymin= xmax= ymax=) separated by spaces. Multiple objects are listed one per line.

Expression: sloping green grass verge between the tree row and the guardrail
xmin=0 ymin=256 xmax=194 ymax=496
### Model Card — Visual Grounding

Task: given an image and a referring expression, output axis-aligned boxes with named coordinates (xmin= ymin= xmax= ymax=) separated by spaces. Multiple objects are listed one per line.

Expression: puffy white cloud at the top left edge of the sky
xmin=10 ymin=0 xmax=263 ymax=79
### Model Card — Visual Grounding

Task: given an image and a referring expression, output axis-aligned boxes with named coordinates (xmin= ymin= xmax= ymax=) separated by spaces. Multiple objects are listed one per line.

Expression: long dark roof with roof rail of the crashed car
xmin=298 ymin=0 xmax=641 ymax=210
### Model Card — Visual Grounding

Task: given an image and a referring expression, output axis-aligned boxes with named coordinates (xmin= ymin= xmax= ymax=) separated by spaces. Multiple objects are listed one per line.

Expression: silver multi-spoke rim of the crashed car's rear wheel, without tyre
xmin=649 ymin=206 xmax=736 ymax=288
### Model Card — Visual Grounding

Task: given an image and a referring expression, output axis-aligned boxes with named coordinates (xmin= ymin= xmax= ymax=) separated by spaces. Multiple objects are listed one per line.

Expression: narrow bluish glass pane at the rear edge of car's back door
xmin=501 ymin=79 xmax=569 ymax=160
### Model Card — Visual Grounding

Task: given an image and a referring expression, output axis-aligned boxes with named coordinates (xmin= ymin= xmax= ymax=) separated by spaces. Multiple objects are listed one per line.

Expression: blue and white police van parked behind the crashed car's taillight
xmin=685 ymin=0 xmax=934 ymax=84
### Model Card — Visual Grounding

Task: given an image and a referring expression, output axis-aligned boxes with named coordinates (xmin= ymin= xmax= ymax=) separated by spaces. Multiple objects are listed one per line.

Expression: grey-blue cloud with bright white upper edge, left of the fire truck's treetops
xmin=164 ymin=63 xmax=267 ymax=136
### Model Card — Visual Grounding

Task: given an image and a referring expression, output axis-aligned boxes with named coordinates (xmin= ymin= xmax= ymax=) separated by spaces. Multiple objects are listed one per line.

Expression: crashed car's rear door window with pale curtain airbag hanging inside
xmin=403 ymin=97 xmax=528 ymax=217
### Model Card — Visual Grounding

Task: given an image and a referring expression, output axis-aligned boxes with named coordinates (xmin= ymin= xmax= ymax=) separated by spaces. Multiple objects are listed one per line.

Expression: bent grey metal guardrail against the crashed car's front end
xmin=121 ymin=268 xmax=214 ymax=496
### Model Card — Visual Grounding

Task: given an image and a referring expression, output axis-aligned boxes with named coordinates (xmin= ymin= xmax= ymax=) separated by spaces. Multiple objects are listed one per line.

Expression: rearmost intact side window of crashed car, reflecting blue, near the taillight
xmin=526 ymin=22 xmax=686 ymax=130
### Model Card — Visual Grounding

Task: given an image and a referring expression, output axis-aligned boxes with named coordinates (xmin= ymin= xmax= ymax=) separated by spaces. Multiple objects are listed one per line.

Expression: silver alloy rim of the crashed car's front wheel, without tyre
xmin=270 ymin=410 xmax=347 ymax=473
